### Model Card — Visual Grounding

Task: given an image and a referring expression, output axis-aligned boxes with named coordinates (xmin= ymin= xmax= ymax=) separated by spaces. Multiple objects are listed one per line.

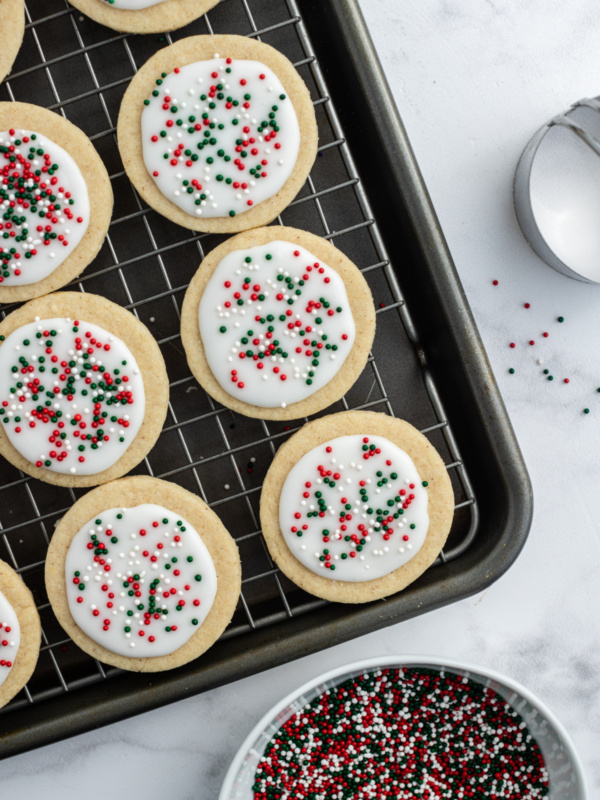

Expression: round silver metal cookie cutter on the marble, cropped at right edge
xmin=514 ymin=98 xmax=600 ymax=283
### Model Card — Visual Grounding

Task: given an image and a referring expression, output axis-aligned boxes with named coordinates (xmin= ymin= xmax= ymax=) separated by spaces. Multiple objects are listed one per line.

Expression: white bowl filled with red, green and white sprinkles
xmin=219 ymin=656 xmax=588 ymax=800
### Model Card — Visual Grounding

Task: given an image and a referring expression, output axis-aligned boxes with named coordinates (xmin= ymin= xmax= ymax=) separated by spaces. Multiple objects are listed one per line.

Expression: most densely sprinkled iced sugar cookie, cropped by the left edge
xmin=0 ymin=103 xmax=113 ymax=303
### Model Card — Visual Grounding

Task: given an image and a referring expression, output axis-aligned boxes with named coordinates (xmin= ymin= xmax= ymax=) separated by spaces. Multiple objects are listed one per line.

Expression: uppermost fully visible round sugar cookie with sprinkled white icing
xmin=117 ymin=36 xmax=318 ymax=233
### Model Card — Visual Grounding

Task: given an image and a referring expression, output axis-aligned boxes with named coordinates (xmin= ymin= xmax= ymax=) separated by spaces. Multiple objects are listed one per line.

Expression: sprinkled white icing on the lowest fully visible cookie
xmin=65 ymin=503 xmax=217 ymax=658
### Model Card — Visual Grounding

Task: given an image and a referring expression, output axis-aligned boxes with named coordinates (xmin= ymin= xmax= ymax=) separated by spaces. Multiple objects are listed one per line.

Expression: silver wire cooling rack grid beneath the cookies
xmin=0 ymin=0 xmax=478 ymax=713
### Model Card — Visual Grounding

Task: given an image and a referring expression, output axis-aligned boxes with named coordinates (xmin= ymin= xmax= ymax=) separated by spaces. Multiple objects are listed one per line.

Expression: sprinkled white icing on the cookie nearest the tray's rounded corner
xmin=279 ymin=435 xmax=429 ymax=582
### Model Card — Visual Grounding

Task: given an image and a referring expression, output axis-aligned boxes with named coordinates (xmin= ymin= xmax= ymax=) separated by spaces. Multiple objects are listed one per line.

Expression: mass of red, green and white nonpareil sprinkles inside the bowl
xmin=252 ymin=667 xmax=549 ymax=800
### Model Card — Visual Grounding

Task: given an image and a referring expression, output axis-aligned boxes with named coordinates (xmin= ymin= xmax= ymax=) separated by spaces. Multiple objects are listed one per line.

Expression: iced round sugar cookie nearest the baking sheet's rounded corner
xmin=260 ymin=411 xmax=454 ymax=603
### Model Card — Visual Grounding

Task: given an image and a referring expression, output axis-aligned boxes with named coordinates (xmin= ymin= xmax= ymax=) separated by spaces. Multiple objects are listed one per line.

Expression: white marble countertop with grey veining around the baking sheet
xmin=0 ymin=0 xmax=600 ymax=800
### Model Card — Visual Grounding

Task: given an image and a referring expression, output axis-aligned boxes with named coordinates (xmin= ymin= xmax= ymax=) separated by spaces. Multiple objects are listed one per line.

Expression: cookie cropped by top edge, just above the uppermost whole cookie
xmin=71 ymin=0 xmax=219 ymax=33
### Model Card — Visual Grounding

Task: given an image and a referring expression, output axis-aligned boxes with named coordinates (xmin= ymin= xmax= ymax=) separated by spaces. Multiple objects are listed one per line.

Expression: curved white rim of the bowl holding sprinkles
xmin=219 ymin=654 xmax=588 ymax=800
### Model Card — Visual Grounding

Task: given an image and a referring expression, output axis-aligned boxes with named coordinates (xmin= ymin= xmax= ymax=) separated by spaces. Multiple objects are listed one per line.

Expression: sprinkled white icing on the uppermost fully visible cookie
xmin=142 ymin=56 xmax=300 ymax=217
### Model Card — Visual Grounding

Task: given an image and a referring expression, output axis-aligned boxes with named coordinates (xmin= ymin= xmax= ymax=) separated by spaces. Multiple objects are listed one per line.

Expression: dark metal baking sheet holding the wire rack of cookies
xmin=0 ymin=0 xmax=532 ymax=757
